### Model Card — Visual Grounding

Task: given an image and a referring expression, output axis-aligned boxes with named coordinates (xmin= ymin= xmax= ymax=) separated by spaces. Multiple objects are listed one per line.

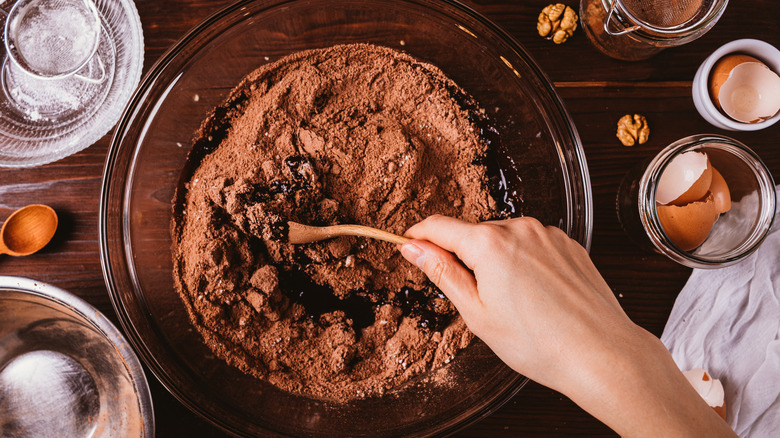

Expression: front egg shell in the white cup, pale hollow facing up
xmin=718 ymin=62 xmax=780 ymax=123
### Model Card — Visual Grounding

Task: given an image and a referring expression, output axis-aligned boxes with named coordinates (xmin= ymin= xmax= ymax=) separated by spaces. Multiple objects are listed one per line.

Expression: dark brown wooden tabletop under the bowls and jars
xmin=0 ymin=0 xmax=780 ymax=437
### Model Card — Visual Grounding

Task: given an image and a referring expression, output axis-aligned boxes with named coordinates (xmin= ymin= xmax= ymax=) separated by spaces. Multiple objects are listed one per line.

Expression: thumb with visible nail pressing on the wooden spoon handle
xmin=400 ymin=240 xmax=479 ymax=313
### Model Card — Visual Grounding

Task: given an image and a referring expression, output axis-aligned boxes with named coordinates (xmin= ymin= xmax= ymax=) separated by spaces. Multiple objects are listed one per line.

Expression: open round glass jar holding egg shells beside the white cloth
xmin=617 ymin=134 xmax=777 ymax=268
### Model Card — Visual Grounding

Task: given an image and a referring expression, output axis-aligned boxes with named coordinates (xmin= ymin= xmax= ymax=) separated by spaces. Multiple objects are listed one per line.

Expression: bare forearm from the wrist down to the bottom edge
xmin=567 ymin=326 xmax=734 ymax=437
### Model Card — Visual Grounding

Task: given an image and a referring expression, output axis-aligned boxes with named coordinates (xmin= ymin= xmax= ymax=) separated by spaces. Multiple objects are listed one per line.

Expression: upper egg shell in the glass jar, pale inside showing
xmin=655 ymin=151 xmax=712 ymax=205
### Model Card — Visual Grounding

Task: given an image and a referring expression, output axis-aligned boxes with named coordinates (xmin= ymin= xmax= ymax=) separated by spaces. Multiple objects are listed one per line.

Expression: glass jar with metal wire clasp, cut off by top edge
xmin=580 ymin=0 xmax=728 ymax=61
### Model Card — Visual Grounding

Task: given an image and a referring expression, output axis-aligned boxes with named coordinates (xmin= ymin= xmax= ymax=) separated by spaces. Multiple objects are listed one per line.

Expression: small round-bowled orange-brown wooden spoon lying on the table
xmin=0 ymin=204 xmax=57 ymax=256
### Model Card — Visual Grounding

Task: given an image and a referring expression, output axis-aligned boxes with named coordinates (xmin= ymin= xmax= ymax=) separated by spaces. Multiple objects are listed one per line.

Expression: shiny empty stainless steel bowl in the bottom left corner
xmin=0 ymin=276 xmax=154 ymax=438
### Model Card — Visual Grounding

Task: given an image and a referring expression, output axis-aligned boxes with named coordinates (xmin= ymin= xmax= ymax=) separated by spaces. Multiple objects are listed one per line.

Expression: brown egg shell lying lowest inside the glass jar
xmin=657 ymin=194 xmax=720 ymax=251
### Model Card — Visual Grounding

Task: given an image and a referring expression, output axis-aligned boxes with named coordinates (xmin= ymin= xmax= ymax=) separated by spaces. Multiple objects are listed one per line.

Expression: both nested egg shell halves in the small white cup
xmin=710 ymin=55 xmax=780 ymax=123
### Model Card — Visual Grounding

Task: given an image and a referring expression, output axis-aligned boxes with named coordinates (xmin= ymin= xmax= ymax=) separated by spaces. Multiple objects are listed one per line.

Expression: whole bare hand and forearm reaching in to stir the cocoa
xmin=401 ymin=216 xmax=733 ymax=436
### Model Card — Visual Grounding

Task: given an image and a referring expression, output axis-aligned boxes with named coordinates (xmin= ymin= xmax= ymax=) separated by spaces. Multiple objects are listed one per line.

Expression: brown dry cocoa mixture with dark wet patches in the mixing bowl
xmin=172 ymin=44 xmax=520 ymax=401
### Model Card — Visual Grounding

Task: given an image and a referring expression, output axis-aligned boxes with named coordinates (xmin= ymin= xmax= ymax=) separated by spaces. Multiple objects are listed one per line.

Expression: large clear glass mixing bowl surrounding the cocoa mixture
xmin=100 ymin=0 xmax=593 ymax=437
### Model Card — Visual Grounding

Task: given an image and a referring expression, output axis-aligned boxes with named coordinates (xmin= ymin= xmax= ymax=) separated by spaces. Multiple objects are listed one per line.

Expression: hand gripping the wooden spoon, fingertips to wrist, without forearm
xmin=401 ymin=216 xmax=636 ymax=390
